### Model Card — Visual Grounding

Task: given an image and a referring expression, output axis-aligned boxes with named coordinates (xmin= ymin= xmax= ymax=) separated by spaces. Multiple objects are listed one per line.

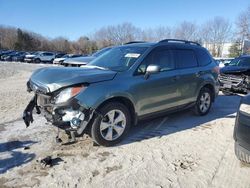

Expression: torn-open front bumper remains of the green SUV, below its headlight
xmin=23 ymin=89 xmax=94 ymax=135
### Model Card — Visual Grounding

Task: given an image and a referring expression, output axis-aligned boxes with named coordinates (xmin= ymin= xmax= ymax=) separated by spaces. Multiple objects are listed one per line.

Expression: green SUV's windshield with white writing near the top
xmin=89 ymin=46 xmax=147 ymax=72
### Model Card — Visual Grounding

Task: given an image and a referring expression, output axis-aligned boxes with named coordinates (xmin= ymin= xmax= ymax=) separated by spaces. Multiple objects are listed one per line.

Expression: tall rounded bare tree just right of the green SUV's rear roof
xmin=201 ymin=17 xmax=232 ymax=56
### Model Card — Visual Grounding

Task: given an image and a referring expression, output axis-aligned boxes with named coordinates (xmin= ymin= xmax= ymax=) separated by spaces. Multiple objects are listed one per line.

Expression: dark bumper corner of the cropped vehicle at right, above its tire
xmin=234 ymin=111 xmax=250 ymax=151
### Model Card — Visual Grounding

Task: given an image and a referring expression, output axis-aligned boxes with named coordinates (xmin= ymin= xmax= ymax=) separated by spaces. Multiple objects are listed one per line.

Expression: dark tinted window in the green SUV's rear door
xmin=174 ymin=49 xmax=198 ymax=69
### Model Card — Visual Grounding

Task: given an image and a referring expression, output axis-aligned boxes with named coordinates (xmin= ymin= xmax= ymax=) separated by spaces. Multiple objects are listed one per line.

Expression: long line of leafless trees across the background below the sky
xmin=0 ymin=6 xmax=250 ymax=56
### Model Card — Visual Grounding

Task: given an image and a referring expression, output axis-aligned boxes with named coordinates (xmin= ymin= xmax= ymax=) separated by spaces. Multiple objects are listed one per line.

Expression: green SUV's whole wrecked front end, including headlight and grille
xmin=23 ymin=80 xmax=94 ymax=135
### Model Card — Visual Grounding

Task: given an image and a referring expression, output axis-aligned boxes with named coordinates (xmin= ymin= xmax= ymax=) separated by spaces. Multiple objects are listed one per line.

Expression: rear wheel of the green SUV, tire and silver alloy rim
xmin=194 ymin=87 xmax=212 ymax=116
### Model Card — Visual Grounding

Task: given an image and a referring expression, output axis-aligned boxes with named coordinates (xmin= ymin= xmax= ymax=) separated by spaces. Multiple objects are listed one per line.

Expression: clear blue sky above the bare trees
xmin=0 ymin=0 xmax=250 ymax=40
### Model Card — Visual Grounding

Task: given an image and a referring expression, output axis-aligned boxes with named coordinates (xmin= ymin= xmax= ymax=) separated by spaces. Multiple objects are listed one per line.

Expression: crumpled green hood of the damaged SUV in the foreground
xmin=30 ymin=66 xmax=116 ymax=92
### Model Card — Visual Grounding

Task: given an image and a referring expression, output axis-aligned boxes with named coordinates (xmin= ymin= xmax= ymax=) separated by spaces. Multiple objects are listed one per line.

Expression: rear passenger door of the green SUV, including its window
xmin=174 ymin=48 xmax=201 ymax=104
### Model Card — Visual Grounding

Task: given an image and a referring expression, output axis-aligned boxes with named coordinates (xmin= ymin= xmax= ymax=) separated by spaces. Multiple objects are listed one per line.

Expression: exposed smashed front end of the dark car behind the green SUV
xmin=219 ymin=74 xmax=250 ymax=94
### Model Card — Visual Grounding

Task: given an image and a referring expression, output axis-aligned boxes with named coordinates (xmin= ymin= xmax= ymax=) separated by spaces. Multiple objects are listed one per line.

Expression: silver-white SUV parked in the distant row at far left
xmin=24 ymin=52 xmax=55 ymax=63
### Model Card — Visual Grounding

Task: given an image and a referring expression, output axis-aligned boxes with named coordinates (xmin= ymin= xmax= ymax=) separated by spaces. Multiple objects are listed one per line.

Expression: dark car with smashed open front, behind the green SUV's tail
xmin=219 ymin=55 xmax=250 ymax=93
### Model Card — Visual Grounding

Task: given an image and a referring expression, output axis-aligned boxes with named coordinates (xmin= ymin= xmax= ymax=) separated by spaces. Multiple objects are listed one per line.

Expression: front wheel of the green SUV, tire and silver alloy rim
xmin=91 ymin=102 xmax=131 ymax=146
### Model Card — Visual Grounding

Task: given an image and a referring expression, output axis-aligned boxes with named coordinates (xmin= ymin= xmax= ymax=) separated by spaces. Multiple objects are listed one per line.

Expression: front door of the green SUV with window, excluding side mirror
xmin=132 ymin=47 xmax=181 ymax=116
